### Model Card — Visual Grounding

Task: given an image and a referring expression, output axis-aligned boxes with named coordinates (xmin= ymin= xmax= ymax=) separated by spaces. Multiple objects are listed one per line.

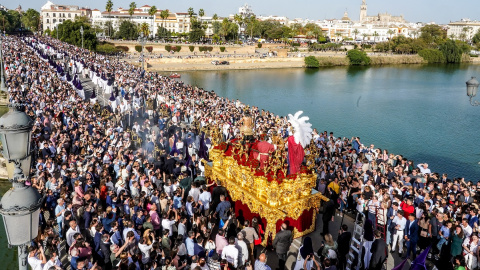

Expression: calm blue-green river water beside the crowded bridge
xmin=177 ymin=65 xmax=480 ymax=182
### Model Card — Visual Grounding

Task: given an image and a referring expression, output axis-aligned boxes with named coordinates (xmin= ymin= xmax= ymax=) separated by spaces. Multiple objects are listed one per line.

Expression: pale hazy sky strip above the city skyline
xmin=6 ymin=0 xmax=480 ymax=24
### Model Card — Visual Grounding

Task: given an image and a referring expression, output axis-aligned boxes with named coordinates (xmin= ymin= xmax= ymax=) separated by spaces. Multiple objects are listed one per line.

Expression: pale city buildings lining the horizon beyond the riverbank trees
xmin=8 ymin=0 xmax=480 ymax=43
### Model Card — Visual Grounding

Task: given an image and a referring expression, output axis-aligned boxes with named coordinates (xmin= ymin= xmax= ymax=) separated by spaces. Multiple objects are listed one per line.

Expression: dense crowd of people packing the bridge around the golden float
xmin=3 ymin=32 xmax=480 ymax=270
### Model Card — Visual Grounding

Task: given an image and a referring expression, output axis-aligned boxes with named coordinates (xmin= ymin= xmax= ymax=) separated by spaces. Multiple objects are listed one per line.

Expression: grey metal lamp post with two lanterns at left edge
xmin=0 ymin=104 xmax=43 ymax=270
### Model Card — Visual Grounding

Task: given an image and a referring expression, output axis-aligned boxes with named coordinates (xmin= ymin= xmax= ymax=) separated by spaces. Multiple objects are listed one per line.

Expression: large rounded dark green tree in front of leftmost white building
xmin=52 ymin=20 xmax=98 ymax=50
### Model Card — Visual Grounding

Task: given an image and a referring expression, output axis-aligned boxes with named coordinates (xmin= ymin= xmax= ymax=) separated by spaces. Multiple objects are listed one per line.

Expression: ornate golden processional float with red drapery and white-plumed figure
xmin=205 ymin=112 xmax=328 ymax=245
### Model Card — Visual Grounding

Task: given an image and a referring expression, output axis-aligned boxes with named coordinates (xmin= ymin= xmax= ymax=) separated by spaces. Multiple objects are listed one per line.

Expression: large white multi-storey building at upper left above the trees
xmin=40 ymin=1 xmax=92 ymax=31
